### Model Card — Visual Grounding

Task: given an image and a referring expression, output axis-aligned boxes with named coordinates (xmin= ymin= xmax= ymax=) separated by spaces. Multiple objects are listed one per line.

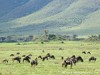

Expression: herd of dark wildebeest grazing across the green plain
xmin=2 ymin=50 xmax=96 ymax=69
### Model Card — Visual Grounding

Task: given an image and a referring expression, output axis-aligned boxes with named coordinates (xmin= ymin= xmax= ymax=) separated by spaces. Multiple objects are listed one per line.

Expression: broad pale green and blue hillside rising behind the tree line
xmin=0 ymin=0 xmax=100 ymax=36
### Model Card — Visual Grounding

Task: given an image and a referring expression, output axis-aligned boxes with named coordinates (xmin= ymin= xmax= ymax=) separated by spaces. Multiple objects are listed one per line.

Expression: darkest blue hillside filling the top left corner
xmin=0 ymin=0 xmax=29 ymax=21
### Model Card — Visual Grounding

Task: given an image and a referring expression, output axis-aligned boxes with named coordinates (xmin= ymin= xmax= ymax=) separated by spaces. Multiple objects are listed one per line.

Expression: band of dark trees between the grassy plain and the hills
xmin=0 ymin=32 xmax=100 ymax=43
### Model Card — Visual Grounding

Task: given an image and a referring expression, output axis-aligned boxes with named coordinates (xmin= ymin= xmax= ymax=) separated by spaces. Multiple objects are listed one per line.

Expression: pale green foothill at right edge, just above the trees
xmin=64 ymin=10 xmax=100 ymax=35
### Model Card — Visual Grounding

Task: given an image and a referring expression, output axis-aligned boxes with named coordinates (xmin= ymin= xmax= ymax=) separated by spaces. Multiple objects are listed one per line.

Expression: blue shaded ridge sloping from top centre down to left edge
xmin=0 ymin=0 xmax=52 ymax=20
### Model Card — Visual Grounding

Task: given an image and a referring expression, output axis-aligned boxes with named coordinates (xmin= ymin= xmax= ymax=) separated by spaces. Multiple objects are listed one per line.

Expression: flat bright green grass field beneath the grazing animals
xmin=0 ymin=41 xmax=100 ymax=75
